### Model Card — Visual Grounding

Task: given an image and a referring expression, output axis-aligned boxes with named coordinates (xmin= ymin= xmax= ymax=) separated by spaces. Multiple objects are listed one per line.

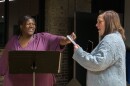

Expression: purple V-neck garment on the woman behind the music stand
xmin=0 ymin=33 xmax=64 ymax=86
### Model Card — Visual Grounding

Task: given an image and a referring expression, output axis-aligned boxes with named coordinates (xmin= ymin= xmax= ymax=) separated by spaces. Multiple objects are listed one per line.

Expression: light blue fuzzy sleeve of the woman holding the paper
xmin=73 ymin=42 xmax=118 ymax=71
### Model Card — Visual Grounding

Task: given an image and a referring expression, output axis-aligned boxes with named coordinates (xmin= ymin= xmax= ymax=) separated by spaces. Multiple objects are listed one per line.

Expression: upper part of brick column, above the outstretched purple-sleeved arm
xmin=45 ymin=0 xmax=68 ymax=35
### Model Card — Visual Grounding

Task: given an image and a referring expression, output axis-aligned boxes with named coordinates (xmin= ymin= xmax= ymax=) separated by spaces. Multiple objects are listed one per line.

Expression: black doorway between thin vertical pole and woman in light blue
xmin=76 ymin=12 xmax=98 ymax=86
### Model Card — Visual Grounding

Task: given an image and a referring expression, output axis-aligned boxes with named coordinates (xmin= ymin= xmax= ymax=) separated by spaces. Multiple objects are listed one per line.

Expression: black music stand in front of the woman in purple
xmin=9 ymin=51 xmax=61 ymax=86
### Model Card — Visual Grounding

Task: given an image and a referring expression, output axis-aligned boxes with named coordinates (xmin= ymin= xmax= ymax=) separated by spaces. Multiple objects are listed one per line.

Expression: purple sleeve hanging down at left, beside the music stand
xmin=0 ymin=36 xmax=13 ymax=75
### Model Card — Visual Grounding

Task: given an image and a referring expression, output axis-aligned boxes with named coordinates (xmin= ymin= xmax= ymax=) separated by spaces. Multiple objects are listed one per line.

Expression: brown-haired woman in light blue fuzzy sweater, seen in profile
xmin=73 ymin=10 xmax=126 ymax=86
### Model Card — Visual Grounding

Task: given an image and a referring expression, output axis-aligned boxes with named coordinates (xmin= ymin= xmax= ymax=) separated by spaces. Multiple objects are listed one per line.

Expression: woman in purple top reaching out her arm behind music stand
xmin=0 ymin=16 xmax=76 ymax=86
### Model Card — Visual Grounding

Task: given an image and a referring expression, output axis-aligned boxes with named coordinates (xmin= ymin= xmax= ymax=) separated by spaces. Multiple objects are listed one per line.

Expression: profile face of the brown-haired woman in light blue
xmin=96 ymin=15 xmax=105 ymax=36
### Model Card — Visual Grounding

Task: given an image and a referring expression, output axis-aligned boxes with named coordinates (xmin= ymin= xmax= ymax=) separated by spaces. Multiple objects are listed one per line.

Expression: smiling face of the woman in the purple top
xmin=20 ymin=19 xmax=36 ymax=36
